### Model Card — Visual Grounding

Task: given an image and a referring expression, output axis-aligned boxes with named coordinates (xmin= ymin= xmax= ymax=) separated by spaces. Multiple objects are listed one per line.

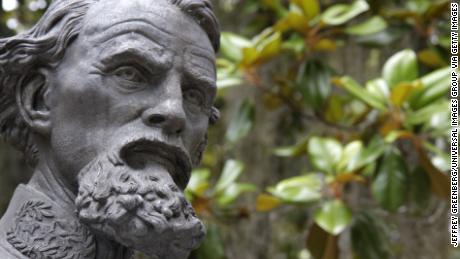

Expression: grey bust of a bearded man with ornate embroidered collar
xmin=0 ymin=0 xmax=219 ymax=259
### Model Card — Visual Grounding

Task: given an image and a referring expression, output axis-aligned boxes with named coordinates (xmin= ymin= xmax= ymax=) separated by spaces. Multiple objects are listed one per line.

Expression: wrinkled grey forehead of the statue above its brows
xmin=81 ymin=0 xmax=215 ymax=59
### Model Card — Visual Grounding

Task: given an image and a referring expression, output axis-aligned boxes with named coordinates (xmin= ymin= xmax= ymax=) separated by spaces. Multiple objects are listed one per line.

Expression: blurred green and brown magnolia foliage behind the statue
xmin=0 ymin=0 xmax=460 ymax=259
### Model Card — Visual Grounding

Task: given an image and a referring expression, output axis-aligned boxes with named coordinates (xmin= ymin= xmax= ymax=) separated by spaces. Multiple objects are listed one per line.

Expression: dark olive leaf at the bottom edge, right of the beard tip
xmin=191 ymin=224 xmax=227 ymax=259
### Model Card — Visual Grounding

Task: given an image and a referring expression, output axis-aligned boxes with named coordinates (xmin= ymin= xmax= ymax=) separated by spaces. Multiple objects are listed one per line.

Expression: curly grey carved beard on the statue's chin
xmin=75 ymin=152 xmax=205 ymax=259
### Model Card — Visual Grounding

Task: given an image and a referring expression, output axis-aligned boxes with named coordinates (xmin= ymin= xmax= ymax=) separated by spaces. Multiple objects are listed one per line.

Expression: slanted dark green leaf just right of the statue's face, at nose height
xmin=225 ymin=100 xmax=255 ymax=143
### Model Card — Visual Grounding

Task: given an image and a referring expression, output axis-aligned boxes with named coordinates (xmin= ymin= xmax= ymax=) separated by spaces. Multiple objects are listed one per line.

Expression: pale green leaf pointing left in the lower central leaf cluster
xmin=268 ymin=174 xmax=322 ymax=203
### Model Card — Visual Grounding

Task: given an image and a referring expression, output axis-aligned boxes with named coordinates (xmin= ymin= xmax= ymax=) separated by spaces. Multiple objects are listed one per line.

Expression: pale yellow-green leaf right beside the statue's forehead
xmin=220 ymin=32 xmax=251 ymax=62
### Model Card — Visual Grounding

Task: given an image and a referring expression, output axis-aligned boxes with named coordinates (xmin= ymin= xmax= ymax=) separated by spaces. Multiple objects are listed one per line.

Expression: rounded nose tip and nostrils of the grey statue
xmin=142 ymin=99 xmax=186 ymax=135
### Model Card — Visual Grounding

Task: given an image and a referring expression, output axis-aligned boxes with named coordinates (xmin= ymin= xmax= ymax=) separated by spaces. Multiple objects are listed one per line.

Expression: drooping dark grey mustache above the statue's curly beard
xmin=108 ymin=134 xmax=192 ymax=190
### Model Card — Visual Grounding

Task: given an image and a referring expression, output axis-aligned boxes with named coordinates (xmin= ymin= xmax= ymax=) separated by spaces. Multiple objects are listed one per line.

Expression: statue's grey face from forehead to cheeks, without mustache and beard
xmin=47 ymin=0 xmax=216 ymax=188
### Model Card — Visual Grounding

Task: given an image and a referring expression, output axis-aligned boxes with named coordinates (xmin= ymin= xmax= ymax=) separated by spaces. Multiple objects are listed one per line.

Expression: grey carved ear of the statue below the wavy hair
xmin=16 ymin=69 xmax=51 ymax=136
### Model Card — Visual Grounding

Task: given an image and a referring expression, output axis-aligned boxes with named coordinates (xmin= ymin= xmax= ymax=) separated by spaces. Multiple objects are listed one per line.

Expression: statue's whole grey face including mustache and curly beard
xmin=40 ymin=0 xmax=216 ymax=259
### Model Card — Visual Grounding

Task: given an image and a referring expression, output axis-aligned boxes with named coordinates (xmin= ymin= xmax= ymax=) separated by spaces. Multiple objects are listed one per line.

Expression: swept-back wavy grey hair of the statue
xmin=0 ymin=0 xmax=220 ymax=164
